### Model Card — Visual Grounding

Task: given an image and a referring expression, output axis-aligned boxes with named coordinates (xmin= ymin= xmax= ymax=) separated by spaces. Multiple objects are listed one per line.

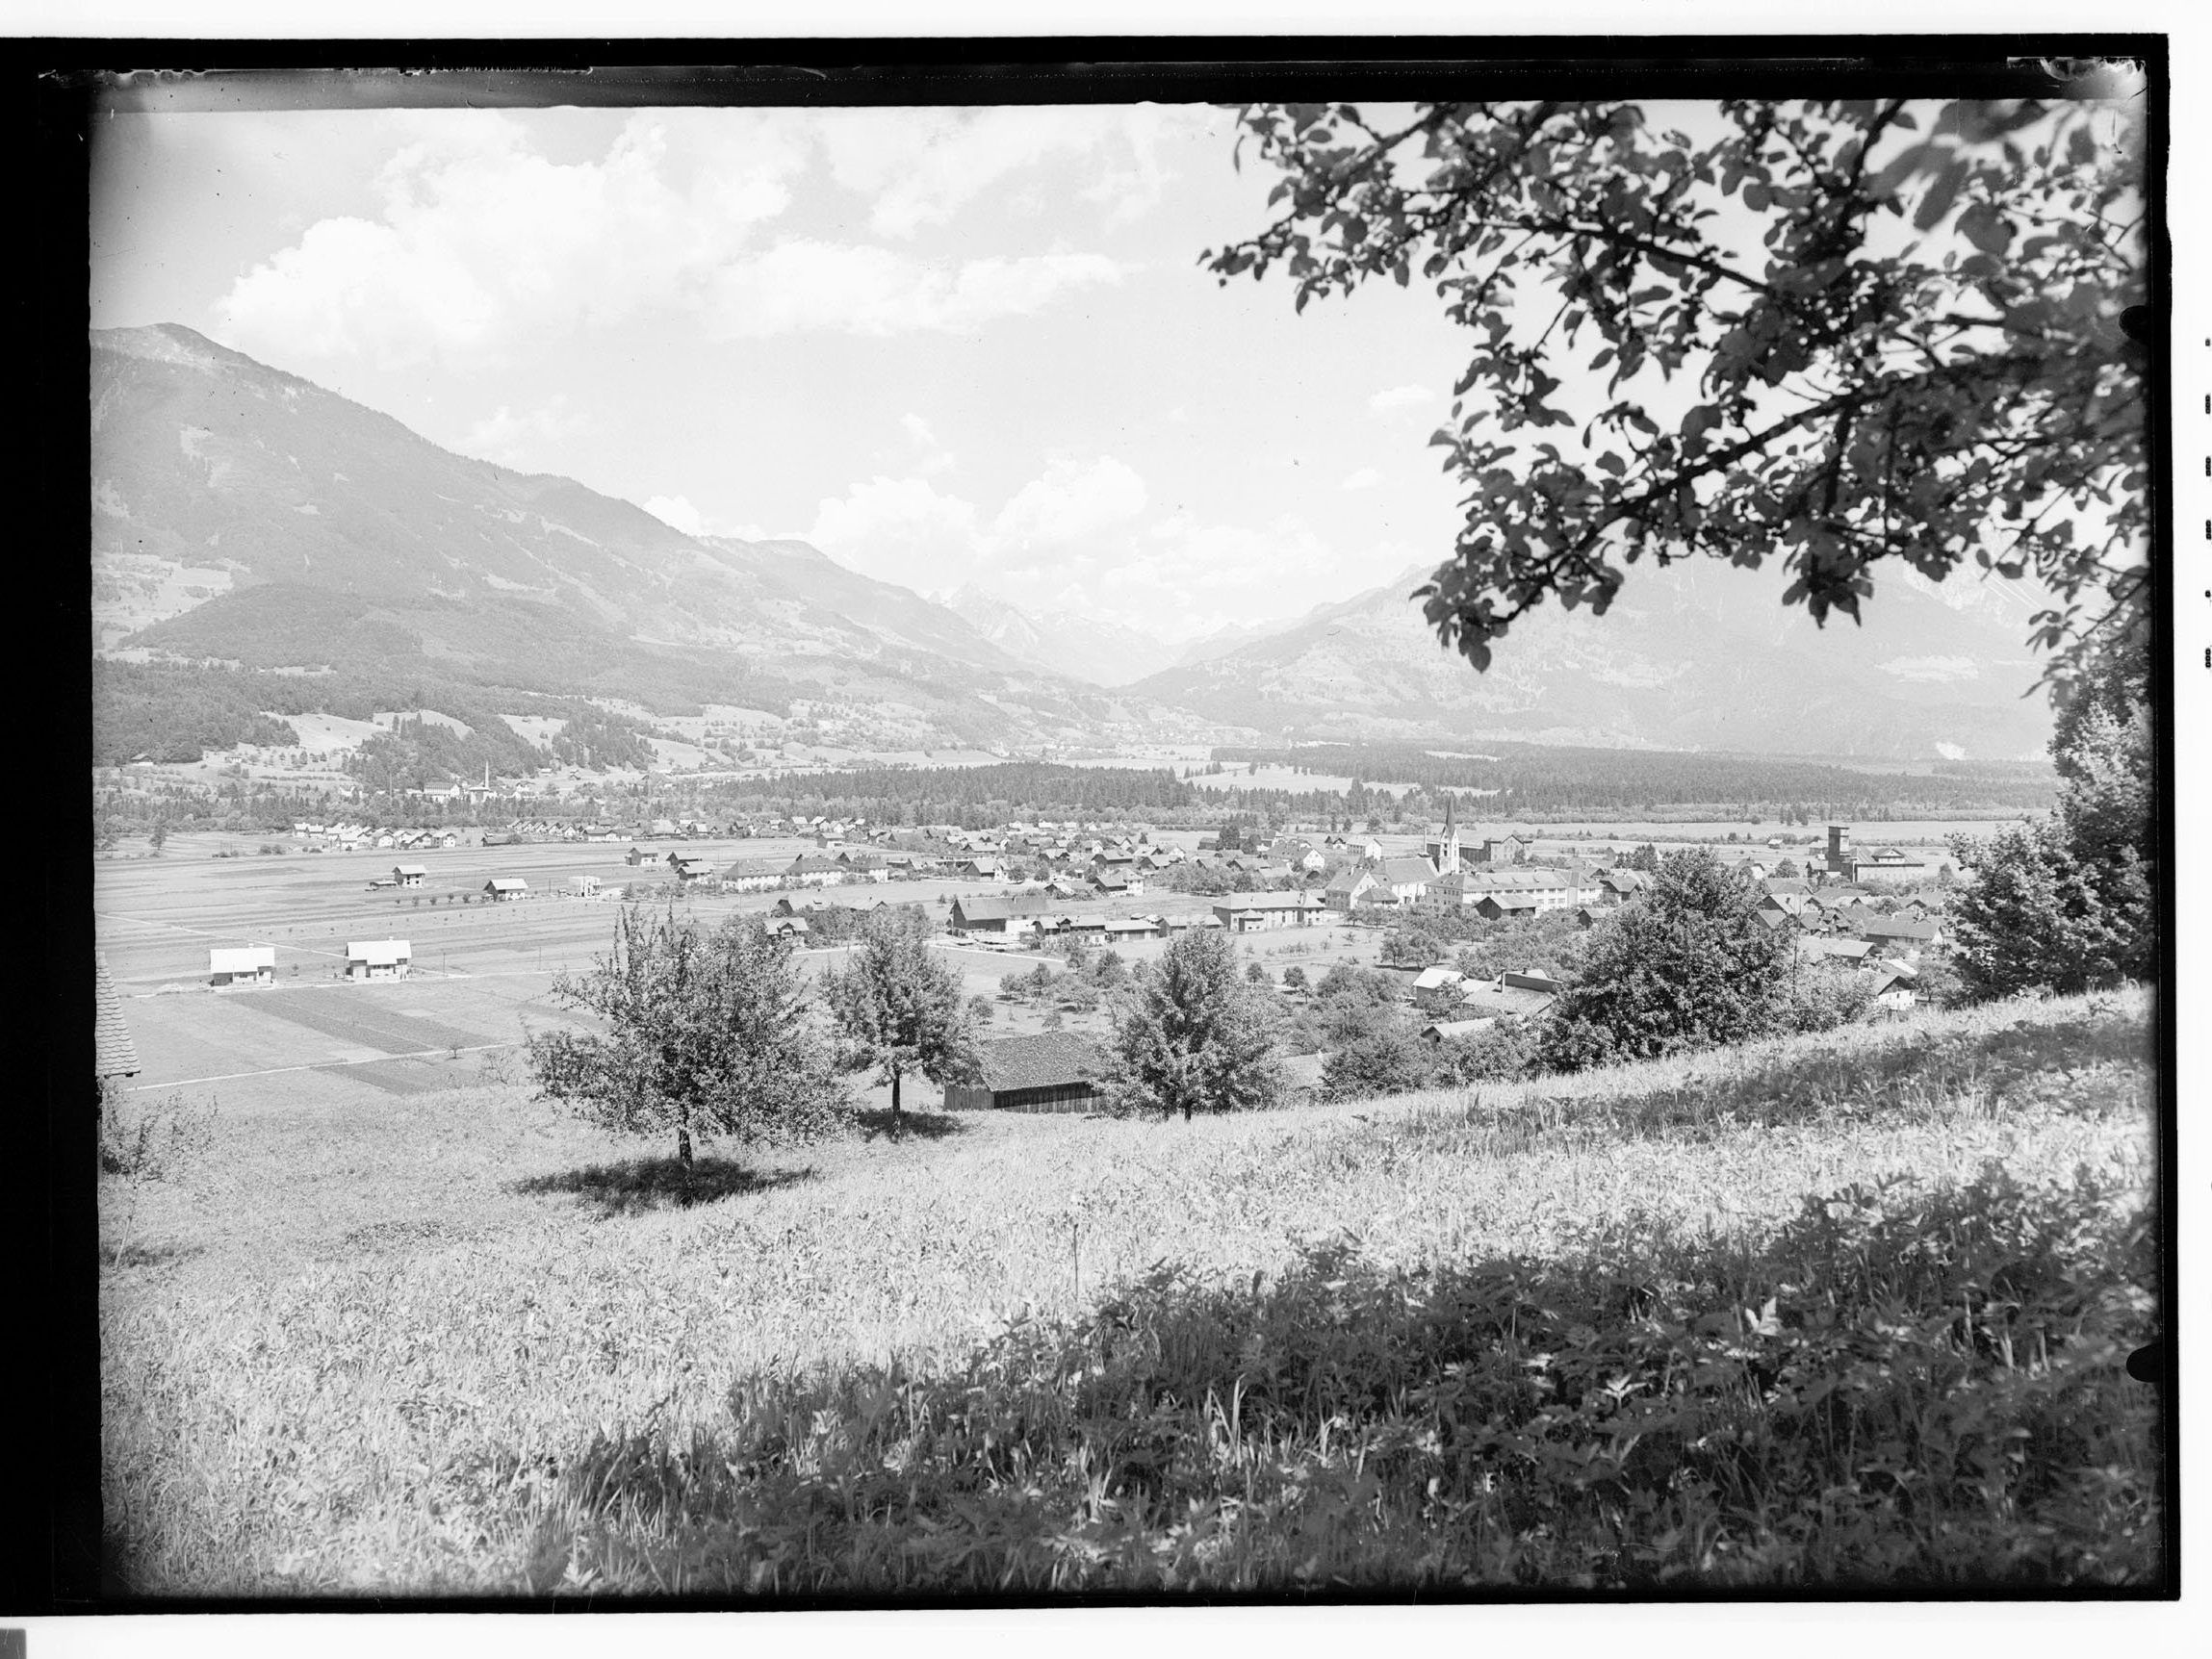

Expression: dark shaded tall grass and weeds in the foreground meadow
xmin=533 ymin=1170 xmax=2159 ymax=1595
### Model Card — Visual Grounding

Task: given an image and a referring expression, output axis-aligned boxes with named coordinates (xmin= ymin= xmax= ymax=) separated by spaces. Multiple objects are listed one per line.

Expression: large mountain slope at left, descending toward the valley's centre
xmin=93 ymin=325 xmax=1194 ymax=741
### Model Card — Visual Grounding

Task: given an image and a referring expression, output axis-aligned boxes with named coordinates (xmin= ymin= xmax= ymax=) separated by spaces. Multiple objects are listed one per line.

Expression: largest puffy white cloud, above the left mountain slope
xmin=217 ymin=111 xmax=808 ymax=365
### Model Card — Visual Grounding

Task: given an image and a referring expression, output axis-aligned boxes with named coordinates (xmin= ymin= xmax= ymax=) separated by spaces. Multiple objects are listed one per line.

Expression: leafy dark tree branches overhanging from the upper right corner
xmin=1205 ymin=86 xmax=2150 ymax=679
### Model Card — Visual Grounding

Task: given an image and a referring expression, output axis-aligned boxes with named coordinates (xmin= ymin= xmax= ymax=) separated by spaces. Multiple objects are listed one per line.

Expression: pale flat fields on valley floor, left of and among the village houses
xmin=93 ymin=836 xmax=1380 ymax=1112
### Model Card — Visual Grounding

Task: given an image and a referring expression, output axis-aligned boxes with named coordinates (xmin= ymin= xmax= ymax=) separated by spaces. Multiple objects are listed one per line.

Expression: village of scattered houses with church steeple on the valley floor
xmin=138 ymin=799 xmax=1953 ymax=1110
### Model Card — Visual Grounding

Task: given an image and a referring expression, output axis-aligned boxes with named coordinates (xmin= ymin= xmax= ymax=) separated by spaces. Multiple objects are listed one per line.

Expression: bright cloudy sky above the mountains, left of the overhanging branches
xmin=90 ymin=104 xmax=1495 ymax=642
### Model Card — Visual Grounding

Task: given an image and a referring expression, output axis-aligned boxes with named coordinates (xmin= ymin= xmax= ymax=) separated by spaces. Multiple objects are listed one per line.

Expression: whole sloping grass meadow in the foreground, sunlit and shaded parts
xmin=102 ymin=998 xmax=2159 ymax=1595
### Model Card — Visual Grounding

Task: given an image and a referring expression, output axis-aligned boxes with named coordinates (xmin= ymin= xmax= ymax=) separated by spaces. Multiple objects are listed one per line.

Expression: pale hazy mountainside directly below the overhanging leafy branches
xmin=1130 ymin=564 xmax=2050 ymax=758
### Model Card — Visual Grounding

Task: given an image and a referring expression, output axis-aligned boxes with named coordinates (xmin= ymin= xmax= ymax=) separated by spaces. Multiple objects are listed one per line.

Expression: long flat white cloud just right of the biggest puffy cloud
xmin=707 ymin=242 xmax=1123 ymax=339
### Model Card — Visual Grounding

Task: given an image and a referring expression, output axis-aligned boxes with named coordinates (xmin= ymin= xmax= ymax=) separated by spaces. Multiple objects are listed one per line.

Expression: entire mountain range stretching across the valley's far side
xmin=90 ymin=325 xmax=2048 ymax=758
